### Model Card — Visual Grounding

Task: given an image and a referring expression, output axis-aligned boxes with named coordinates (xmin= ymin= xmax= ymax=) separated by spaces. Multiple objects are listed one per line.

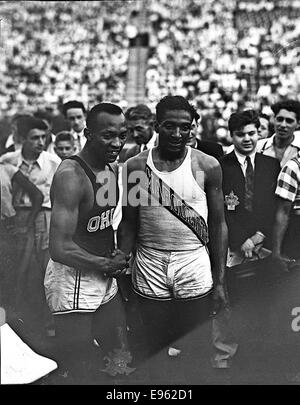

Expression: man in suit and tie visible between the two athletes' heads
xmin=119 ymin=104 xmax=156 ymax=162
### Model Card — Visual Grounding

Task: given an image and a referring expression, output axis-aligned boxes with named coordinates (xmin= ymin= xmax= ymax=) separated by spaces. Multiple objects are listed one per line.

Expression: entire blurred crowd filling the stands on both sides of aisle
xmin=0 ymin=0 xmax=300 ymax=145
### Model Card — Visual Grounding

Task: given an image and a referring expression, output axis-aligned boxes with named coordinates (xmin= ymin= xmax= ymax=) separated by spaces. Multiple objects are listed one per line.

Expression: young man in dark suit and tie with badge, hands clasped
xmin=220 ymin=110 xmax=280 ymax=266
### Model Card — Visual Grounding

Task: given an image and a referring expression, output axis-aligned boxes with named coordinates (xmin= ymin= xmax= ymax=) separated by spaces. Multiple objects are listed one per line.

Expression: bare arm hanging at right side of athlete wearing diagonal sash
xmin=205 ymin=159 xmax=228 ymax=311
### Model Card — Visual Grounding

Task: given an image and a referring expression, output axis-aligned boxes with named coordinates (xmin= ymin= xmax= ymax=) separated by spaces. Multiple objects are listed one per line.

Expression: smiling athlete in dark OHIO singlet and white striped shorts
xmin=44 ymin=103 xmax=130 ymax=383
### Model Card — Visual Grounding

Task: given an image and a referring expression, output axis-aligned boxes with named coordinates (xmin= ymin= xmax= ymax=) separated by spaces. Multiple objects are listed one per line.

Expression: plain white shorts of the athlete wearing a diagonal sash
xmin=132 ymin=241 xmax=213 ymax=300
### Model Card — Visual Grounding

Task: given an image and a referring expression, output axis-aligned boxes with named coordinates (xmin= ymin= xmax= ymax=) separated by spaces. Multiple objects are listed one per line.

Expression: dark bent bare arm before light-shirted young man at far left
xmin=13 ymin=170 xmax=44 ymax=228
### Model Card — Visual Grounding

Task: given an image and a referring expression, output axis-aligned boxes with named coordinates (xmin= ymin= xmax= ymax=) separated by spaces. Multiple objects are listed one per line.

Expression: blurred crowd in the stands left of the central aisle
xmin=0 ymin=1 xmax=135 ymax=114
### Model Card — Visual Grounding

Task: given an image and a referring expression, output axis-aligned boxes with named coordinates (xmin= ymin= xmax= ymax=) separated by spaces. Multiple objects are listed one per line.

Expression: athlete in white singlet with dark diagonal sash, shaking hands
xmin=119 ymin=96 xmax=227 ymax=362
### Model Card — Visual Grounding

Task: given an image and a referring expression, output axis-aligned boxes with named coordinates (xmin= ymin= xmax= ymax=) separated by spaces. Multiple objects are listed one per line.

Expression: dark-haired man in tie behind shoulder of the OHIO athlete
xmin=63 ymin=100 xmax=86 ymax=153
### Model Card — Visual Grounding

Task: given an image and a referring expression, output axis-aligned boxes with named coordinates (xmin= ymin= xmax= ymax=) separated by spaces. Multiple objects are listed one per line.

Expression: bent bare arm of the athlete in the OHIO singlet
xmin=49 ymin=168 xmax=126 ymax=274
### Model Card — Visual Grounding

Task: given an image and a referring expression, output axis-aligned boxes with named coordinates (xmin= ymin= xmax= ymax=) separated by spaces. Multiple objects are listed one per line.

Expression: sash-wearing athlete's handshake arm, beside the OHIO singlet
xmin=118 ymin=161 xmax=138 ymax=254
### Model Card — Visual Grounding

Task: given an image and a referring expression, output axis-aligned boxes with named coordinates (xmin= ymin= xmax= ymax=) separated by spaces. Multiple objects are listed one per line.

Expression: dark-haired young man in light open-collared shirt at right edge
xmin=257 ymin=100 xmax=300 ymax=167
